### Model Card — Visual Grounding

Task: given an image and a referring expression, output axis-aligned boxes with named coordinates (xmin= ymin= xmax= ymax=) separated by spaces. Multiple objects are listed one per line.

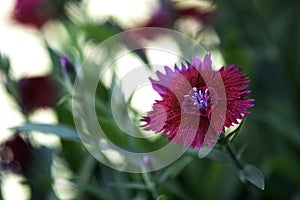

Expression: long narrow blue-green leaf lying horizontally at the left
xmin=10 ymin=123 xmax=80 ymax=141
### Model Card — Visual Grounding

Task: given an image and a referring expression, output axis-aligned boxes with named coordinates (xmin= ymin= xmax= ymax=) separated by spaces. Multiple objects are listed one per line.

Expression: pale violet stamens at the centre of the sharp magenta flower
xmin=191 ymin=87 xmax=210 ymax=111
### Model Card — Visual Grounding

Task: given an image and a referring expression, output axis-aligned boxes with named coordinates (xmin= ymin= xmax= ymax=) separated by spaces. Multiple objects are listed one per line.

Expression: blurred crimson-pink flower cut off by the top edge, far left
xmin=12 ymin=0 xmax=59 ymax=28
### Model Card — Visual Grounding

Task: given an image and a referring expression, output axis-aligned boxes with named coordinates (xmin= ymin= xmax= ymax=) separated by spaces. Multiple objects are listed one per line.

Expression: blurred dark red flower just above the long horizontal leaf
xmin=19 ymin=76 xmax=57 ymax=113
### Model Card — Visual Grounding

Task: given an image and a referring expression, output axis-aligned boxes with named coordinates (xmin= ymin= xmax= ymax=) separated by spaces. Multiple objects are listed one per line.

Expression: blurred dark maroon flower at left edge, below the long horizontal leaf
xmin=0 ymin=134 xmax=33 ymax=171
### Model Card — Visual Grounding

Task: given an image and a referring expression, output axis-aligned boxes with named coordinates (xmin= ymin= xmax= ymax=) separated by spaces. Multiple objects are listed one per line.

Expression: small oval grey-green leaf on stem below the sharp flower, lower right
xmin=242 ymin=165 xmax=265 ymax=190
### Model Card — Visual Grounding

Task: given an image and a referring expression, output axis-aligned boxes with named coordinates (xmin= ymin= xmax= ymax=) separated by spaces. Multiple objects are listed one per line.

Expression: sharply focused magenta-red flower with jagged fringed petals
xmin=141 ymin=54 xmax=254 ymax=149
